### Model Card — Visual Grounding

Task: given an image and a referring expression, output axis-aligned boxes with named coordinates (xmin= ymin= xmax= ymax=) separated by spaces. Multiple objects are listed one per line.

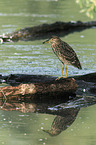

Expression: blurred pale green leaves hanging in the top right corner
xmin=76 ymin=0 xmax=96 ymax=18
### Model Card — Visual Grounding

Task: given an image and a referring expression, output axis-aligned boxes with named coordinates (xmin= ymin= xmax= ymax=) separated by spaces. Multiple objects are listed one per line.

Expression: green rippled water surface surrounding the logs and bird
xmin=0 ymin=0 xmax=96 ymax=145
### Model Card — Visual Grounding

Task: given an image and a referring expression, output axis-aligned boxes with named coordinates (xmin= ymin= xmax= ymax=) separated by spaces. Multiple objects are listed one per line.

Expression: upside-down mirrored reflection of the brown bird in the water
xmin=43 ymin=108 xmax=80 ymax=136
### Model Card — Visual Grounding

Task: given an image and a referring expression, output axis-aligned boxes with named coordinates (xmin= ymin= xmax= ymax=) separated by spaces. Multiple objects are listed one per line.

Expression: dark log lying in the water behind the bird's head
xmin=0 ymin=21 xmax=96 ymax=43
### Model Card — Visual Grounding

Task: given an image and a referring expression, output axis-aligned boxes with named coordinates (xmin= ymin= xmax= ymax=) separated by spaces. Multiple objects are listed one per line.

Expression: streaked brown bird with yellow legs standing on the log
xmin=43 ymin=36 xmax=82 ymax=79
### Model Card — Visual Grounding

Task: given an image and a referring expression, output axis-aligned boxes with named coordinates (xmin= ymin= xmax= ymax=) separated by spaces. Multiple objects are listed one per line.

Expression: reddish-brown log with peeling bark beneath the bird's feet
xmin=0 ymin=78 xmax=78 ymax=102
